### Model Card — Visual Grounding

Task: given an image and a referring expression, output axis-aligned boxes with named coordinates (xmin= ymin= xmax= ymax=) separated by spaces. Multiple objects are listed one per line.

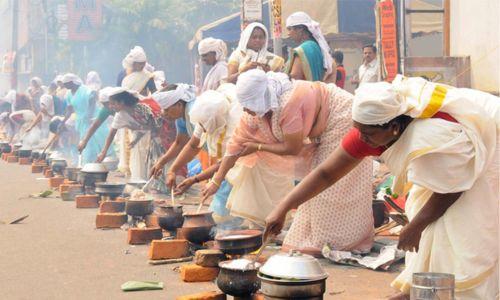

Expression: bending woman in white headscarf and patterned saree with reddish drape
xmin=97 ymin=88 xmax=174 ymax=180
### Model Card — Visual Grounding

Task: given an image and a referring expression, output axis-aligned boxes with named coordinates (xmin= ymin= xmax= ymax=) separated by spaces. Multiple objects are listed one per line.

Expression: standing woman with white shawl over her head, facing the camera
xmin=227 ymin=22 xmax=284 ymax=83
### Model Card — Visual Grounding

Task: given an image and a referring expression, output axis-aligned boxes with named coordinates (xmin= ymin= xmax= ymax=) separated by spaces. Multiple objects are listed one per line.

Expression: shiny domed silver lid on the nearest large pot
xmin=260 ymin=250 xmax=328 ymax=280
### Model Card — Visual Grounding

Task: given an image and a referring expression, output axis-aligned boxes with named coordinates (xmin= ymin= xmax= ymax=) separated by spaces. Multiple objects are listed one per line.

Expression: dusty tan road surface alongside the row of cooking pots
xmin=0 ymin=161 xmax=396 ymax=300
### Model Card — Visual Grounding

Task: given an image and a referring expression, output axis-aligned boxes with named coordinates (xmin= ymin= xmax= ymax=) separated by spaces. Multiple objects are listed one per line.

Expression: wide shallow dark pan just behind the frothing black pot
xmin=215 ymin=230 xmax=262 ymax=255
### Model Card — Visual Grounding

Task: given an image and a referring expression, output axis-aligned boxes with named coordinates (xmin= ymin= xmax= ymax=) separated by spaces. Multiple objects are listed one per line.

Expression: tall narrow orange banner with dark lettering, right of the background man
xmin=378 ymin=0 xmax=399 ymax=82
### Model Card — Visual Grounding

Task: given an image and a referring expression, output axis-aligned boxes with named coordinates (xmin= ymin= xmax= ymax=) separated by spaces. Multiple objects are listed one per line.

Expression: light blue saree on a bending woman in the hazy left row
xmin=68 ymin=85 xmax=113 ymax=164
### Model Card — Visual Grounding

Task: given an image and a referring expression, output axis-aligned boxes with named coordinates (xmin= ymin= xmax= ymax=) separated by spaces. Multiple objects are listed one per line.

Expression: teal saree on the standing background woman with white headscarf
xmin=286 ymin=40 xmax=325 ymax=81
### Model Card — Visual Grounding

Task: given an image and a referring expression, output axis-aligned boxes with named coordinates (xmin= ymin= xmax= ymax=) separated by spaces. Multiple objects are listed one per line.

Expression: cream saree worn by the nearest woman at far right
xmin=381 ymin=119 xmax=498 ymax=299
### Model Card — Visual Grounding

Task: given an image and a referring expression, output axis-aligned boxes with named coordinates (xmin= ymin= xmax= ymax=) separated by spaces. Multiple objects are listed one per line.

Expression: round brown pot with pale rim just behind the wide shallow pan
xmin=182 ymin=211 xmax=215 ymax=244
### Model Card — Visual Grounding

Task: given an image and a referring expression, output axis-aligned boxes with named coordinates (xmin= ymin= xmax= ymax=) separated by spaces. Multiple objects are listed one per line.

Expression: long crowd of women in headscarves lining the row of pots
xmin=0 ymin=12 xmax=500 ymax=299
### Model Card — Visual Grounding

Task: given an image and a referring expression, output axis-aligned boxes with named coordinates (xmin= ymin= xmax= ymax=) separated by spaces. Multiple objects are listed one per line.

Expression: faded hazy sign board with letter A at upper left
xmin=67 ymin=0 xmax=102 ymax=41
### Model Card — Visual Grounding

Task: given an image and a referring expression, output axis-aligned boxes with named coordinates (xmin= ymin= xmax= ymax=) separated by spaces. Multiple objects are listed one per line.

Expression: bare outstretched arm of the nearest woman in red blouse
xmin=266 ymin=147 xmax=362 ymax=235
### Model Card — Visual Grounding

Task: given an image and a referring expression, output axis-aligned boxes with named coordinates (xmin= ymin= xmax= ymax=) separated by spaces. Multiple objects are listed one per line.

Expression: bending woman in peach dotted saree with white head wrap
xmin=201 ymin=70 xmax=373 ymax=255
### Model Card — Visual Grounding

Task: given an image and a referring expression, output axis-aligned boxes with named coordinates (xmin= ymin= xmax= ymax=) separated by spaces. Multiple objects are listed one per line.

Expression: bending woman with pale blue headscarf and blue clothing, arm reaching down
xmin=150 ymin=83 xmax=196 ymax=177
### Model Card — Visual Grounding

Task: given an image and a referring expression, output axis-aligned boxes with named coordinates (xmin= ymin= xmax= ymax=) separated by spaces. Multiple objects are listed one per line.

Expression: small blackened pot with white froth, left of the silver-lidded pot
xmin=217 ymin=260 xmax=260 ymax=297
